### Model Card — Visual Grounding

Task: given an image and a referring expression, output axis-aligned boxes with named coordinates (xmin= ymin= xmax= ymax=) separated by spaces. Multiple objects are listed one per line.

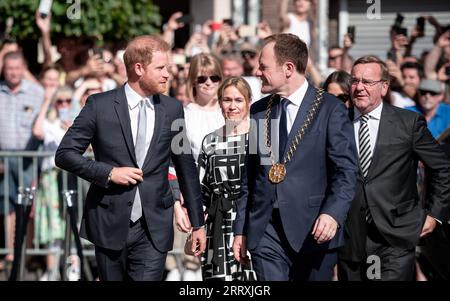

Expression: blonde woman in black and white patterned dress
xmin=198 ymin=77 xmax=255 ymax=281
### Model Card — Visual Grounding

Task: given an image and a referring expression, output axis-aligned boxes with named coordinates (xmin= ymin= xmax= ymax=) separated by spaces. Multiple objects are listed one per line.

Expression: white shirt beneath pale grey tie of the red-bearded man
xmin=125 ymin=83 xmax=155 ymax=153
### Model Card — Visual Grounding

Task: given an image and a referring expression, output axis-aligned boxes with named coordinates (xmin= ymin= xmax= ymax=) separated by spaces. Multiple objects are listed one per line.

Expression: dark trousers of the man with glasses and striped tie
xmin=338 ymin=223 xmax=415 ymax=281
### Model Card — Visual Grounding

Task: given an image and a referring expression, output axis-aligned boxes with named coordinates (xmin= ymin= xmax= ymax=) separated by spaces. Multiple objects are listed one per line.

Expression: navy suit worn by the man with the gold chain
xmin=234 ymin=85 xmax=358 ymax=280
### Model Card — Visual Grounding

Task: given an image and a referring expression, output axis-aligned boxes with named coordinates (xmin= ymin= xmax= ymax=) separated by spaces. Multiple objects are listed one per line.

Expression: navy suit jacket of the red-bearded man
xmin=55 ymin=87 xmax=204 ymax=278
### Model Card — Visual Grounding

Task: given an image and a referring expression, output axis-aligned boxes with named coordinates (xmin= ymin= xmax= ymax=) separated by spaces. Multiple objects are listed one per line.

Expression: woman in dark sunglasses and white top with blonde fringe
xmin=184 ymin=53 xmax=225 ymax=161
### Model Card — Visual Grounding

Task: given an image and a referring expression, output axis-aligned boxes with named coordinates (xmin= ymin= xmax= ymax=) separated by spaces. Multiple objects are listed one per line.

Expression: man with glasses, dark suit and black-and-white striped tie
xmin=338 ymin=56 xmax=450 ymax=281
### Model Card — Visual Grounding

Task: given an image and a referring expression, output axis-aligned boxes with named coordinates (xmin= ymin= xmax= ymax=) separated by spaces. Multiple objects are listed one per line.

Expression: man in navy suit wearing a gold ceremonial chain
xmin=233 ymin=34 xmax=358 ymax=281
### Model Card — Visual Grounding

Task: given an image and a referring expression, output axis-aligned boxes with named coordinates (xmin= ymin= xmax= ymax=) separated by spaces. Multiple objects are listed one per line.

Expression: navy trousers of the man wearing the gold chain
xmin=251 ymin=209 xmax=337 ymax=281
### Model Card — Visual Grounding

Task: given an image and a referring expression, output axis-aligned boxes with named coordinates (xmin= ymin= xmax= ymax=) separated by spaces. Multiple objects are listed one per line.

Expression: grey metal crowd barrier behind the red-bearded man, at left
xmin=0 ymin=151 xmax=184 ymax=280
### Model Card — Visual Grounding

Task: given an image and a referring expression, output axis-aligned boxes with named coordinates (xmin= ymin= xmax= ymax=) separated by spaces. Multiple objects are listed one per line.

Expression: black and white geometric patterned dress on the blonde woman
xmin=198 ymin=130 xmax=256 ymax=281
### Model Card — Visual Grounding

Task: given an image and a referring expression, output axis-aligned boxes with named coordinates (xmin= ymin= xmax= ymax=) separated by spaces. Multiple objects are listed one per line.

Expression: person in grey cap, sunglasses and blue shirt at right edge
xmin=407 ymin=79 xmax=450 ymax=139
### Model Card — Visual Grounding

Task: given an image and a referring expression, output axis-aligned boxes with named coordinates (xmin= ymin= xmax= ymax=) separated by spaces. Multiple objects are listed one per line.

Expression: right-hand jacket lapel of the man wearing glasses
xmin=367 ymin=103 xmax=394 ymax=178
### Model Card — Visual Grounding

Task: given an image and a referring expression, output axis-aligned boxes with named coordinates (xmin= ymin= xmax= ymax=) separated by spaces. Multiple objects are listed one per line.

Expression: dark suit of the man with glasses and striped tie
xmin=339 ymin=104 xmax=450 ymax=280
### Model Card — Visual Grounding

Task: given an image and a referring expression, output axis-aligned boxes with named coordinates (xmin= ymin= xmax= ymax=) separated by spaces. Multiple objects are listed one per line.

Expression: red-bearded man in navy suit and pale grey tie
xmin=55 ymin=36 xmax=206 ymax=280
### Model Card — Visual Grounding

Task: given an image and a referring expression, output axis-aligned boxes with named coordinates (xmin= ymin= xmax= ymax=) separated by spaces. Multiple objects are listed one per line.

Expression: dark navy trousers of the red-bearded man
xmin=95 ymin=218 xmax=167 ymax=281
